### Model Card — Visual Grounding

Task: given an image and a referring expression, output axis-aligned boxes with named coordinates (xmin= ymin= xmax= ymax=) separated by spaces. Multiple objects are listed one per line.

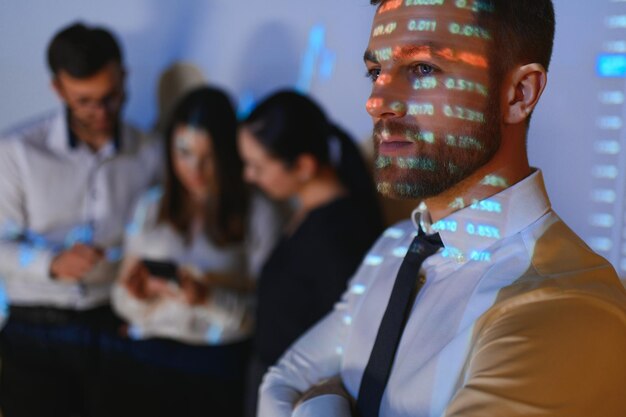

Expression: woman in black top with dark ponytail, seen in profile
xmin=238 ymin=91 xmax=382 ymax=415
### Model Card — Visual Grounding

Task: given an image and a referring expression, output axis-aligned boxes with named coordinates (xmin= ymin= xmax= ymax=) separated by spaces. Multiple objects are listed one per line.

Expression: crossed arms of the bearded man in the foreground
xmin=259 ymin=286 xmax=626 ymax=417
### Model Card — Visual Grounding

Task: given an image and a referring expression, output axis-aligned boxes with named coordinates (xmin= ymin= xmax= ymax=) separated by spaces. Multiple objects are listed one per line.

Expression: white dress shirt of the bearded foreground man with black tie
xmin=258 ymin=171 xmax=626 ymax=417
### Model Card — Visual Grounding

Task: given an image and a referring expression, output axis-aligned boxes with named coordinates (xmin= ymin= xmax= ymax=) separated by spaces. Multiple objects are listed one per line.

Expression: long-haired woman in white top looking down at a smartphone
xmin=102 ymin=87 xmax=279 ymax=417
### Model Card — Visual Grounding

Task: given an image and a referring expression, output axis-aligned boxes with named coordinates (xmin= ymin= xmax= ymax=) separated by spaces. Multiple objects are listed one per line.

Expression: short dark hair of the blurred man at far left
xmin=48 ymin=23 xmax=122 ymax=78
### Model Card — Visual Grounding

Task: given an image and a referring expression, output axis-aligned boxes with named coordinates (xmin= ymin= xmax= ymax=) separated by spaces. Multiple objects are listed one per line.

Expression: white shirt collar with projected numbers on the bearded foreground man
xmin=411 ymin=169 xmax=550 ymax=263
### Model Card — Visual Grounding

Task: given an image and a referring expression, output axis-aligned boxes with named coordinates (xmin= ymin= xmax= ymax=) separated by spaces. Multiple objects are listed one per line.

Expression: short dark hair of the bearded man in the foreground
xmin=371 ymin=0 xmax=555 ymax=75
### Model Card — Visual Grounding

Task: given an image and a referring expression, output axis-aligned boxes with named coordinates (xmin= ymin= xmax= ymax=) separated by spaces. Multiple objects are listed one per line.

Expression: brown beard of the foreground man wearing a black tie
xmin=374 ymin=98 xmax=501 ymax=199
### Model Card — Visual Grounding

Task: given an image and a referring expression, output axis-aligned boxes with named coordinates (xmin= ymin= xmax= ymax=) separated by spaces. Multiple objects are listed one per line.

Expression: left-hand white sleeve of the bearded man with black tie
xmin=258 ymin=292 xmax=349 ymax=417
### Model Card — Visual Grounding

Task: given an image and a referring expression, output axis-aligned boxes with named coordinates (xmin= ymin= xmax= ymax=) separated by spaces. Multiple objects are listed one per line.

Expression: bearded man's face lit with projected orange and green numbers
xmin=365 ymin=0 xmax=500 ymax=199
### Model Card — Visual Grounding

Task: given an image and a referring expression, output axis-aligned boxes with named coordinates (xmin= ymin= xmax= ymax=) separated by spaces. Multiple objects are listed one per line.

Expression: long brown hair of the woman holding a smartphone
xmin=159 ymin=87 xmax=249 ymax=246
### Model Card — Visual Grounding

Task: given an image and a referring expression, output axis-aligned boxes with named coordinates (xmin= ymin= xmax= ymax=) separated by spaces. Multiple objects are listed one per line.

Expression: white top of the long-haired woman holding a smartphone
xmin=112 ymin=188 xmax=280 ymax=345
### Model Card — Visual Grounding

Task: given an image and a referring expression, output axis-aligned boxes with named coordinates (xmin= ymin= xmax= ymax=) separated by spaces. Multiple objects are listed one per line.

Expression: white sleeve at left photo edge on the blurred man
xmin=0 ymin=138 xmax=56 ymax=281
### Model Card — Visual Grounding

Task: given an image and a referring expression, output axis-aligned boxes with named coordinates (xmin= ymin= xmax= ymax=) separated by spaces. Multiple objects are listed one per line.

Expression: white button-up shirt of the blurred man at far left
xmin=0 ymin=111 xmax=161 ymax=310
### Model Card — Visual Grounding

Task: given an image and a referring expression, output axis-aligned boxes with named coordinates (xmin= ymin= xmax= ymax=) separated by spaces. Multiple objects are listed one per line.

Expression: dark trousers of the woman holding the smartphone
xmin=100 ymin=339 xmax=249 ymax=417
